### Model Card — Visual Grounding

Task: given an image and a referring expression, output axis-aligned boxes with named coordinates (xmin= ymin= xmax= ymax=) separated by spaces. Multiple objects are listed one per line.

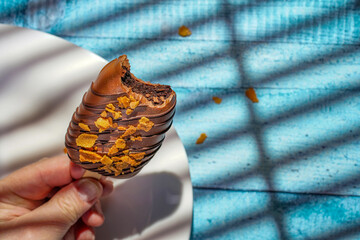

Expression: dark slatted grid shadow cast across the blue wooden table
xmin=0 ymin=0 xmax=360 ymax=240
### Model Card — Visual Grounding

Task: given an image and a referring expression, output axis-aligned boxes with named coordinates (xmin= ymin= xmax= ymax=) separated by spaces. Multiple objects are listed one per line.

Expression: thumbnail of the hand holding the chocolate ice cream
xmin=76 ymin=178 xmax=101 ymax=202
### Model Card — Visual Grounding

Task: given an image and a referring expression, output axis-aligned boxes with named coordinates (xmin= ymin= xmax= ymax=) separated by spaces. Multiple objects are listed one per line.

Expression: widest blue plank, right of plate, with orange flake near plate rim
xmin=174 ymin=88 xmax=360 ymax=195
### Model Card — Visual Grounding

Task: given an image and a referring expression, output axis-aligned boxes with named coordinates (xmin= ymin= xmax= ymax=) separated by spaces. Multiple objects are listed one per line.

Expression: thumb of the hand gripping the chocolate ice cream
xmin=24 ymin=178 xmax=103 ymax=235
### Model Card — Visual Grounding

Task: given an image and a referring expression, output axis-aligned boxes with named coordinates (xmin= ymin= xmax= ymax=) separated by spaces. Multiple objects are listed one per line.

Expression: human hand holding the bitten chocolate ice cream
xmin=0 ymin=155 xmax=113 ymax=240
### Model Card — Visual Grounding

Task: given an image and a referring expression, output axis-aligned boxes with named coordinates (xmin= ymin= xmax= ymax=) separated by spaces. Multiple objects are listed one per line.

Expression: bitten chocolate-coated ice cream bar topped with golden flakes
xmin=65 ymin=55 xmax=176 ymax=178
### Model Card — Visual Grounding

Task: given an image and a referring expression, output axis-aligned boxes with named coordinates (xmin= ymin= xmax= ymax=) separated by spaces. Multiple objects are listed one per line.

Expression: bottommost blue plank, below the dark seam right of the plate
xmin=191 ymin=189 xmax=360 ymax=240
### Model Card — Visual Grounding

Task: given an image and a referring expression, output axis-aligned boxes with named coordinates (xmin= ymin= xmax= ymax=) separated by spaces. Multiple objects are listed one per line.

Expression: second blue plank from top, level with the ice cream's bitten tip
xmin=61 ymin=38 xmax=360 ymax=89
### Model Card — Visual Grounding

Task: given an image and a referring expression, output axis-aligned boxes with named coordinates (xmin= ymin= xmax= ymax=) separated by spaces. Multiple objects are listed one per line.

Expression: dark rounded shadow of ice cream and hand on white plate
xmin=96 ymin=172 xmax=182 ymax=240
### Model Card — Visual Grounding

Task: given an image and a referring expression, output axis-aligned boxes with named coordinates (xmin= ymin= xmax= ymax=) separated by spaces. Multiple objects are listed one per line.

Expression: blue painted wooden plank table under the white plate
xmin=0 ymin=0 xmax=360 ymax=239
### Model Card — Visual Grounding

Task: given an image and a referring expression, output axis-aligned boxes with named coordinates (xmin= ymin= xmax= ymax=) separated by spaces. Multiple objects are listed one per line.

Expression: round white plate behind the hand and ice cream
xmin=0 ymin=24 xmax=193 ymax=240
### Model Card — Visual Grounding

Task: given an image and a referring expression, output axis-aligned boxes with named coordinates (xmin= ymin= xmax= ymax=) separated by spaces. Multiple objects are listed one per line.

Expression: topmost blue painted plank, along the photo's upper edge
xmin=4 ymin=0 xmax=360 ymax=44
